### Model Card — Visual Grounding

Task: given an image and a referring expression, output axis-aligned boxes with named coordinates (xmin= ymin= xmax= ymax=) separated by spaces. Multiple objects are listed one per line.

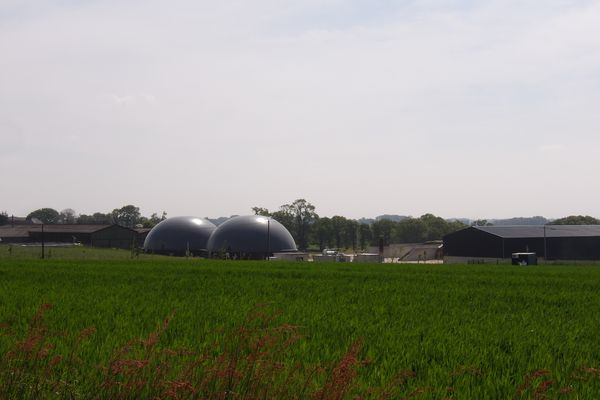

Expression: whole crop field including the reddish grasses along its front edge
xmin=0 ymin=246 xmax=600 ymax=399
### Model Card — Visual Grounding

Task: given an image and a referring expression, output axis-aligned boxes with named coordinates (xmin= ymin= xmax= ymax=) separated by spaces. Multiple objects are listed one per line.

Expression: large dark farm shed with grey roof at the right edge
xmin=444 ymin=225 xmax=600 ymax=263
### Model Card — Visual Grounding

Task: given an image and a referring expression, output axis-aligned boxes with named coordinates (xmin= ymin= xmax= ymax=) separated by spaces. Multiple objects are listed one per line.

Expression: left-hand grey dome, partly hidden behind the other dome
xmin=144 ymin=217 xmax=216 ymax=255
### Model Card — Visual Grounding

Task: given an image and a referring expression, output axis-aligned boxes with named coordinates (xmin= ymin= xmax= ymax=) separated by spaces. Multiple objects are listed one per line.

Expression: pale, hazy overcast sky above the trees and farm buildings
xmin=0 ymin=0 xmax=600 ymax=218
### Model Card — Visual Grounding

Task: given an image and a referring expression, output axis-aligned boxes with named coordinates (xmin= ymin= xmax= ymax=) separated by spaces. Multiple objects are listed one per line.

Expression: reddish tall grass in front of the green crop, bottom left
xmin=0 ymin=304 xmax=406 ymax=400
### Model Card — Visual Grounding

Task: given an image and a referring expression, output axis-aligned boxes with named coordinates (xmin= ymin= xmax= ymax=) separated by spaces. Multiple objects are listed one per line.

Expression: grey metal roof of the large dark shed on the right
xmin=473 ymin=225 xmax=600 ymax=239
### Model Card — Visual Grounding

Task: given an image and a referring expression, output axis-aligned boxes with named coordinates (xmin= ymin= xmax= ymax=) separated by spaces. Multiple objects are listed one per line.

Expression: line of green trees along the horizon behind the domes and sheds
xmin=0 ymin=203 xmax=600 ymax=250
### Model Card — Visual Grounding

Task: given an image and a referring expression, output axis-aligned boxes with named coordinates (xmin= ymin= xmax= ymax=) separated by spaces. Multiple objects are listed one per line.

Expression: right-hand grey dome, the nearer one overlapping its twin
xmin=208 ymin=215 xmax=296 ymax=258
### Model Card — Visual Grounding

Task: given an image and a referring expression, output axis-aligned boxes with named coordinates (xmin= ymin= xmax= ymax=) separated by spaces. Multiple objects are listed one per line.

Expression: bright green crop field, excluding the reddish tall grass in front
xmin=0 ymin=246 xmax=600 ymax=399
